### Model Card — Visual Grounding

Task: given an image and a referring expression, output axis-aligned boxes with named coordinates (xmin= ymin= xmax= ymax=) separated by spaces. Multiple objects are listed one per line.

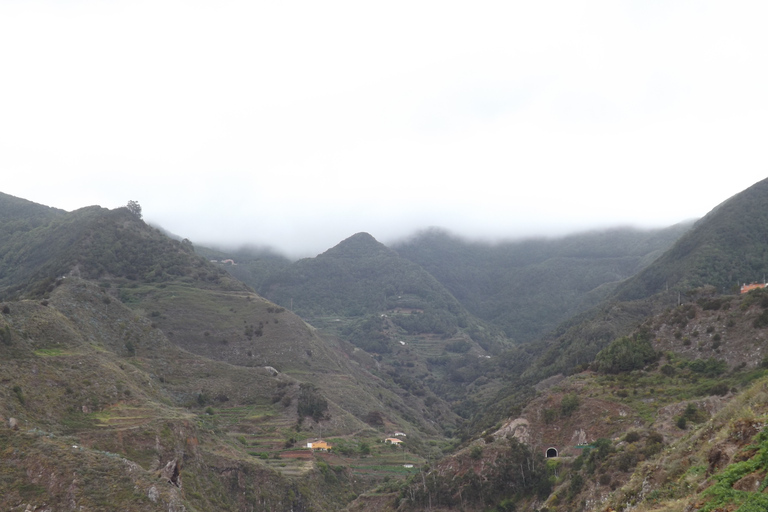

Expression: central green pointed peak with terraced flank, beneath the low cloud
xmin=216 ymin=233 xmax=510 ymax=424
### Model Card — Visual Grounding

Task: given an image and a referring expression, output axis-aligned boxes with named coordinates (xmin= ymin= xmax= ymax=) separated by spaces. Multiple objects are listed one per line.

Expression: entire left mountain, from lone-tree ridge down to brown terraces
xmin=0 ymin=196 xmax=458 ymax=510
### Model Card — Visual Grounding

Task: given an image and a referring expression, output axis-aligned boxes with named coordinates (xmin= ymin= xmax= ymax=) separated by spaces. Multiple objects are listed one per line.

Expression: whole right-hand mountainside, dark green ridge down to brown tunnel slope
xmin=350 ymin=175 xmax=768 ymax=512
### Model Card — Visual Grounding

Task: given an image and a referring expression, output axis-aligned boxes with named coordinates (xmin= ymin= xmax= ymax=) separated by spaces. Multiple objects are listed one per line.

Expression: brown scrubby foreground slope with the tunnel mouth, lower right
xmin=364 ymin=291 xmax=768 ymax=512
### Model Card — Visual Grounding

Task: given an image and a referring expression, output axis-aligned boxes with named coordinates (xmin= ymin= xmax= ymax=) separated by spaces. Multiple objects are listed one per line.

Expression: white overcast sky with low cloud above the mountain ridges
xmin=0 ymin=0 xmax=768 ymax=256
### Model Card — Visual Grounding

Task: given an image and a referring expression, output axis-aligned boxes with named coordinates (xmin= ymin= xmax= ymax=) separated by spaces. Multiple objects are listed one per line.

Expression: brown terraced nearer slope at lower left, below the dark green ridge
xmin=0 ymin=278 xmax=362 ymax=511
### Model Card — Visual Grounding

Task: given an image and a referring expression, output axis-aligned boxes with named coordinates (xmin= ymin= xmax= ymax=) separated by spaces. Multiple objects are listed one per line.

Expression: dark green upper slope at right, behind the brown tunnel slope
xmin=489 ymin=180 xmax=768 ymax=402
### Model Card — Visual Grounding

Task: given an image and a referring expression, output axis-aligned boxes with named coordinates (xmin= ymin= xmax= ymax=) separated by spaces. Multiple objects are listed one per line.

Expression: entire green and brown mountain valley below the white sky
xmin=0 ymin=181 xmax=768 ymax=512
